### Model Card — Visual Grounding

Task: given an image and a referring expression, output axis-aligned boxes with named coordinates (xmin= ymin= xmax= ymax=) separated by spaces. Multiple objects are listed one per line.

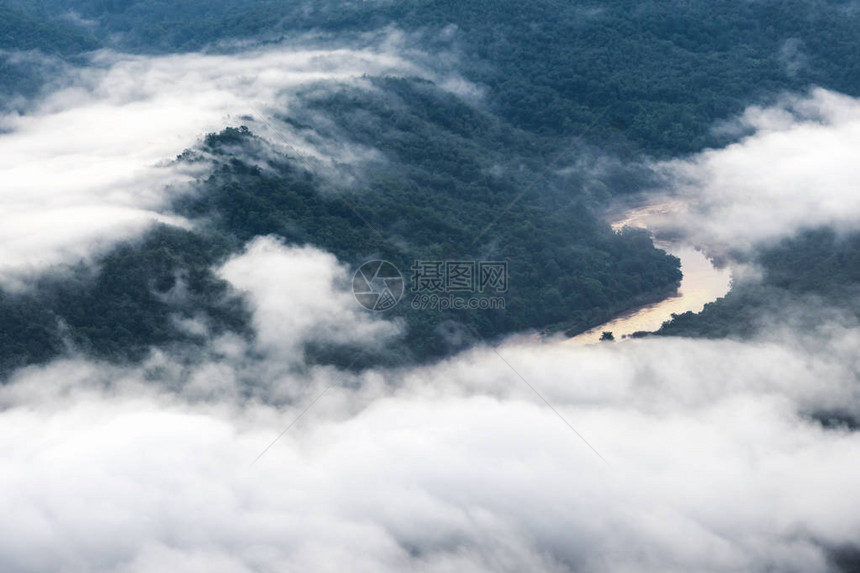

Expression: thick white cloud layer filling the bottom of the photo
xmin=0 ymin=324 xmax=860 ymax=573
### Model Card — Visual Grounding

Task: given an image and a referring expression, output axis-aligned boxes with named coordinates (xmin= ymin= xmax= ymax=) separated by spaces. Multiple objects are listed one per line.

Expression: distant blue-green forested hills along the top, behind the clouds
xmin=6 ymin=0 xmax=860 ymax=155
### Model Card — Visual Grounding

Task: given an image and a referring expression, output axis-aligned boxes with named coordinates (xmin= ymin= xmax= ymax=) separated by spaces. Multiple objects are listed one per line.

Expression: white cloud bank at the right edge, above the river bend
xmin=658 ymin=89 xmax=860 ymax=250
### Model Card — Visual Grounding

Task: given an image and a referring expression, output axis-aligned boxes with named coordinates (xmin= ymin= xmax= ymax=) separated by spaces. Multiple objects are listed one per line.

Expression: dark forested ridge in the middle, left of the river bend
xmin=0 ymin=78 xmax=681 ymax=368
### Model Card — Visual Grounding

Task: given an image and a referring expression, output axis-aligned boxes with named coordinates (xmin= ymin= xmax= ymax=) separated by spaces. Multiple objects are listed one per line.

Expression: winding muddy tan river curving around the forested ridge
xmin=564 ymin=202 xmax=732 ymax=345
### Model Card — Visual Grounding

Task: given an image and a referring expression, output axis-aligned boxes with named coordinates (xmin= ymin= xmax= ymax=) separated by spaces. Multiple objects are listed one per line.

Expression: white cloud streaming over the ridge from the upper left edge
xmin=0 ymin=36 xmax=456 ymax=288
